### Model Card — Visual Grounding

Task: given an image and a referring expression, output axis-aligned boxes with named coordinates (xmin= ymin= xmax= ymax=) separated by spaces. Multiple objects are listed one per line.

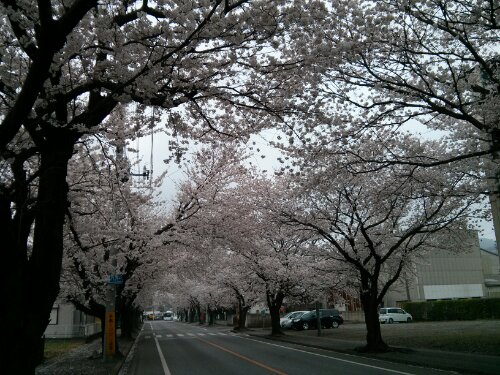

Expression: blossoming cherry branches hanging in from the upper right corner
xmin=288 ymin=0 xmax=500 ymax=161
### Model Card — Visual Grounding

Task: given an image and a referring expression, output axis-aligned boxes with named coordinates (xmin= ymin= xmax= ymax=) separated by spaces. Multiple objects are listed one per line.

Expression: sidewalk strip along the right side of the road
xmin=245 ymin=328 xmax=500 ymax=375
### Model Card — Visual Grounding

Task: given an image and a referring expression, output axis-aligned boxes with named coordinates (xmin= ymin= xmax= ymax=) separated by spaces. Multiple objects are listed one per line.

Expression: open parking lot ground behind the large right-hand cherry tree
xmin=287 ymin=320 xmax=500 ymax=356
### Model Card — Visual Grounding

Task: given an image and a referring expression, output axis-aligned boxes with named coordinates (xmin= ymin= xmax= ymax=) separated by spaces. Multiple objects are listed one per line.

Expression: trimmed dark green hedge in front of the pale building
xmin=400 ymin=298 xmax=500 ymax=321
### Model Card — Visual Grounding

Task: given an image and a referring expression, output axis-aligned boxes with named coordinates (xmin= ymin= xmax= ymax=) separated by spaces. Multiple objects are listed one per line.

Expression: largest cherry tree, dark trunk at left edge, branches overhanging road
xmin=0 ymin=0 xmax=314 ymax=374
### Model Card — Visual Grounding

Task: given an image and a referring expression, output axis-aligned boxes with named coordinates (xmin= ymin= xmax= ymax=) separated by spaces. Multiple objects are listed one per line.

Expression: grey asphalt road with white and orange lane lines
xmin=120 ymin=321 xmax=454 ymax=375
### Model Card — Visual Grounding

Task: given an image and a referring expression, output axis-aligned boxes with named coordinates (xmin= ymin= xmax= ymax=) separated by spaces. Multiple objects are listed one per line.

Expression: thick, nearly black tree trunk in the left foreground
xmin=0 ymin=142 xmax=73 ymax=375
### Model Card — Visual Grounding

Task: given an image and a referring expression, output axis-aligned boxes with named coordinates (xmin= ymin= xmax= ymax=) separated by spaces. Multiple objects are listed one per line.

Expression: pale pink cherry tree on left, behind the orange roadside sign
xmin=59 ymin=135 xmax=159 ymax=344
